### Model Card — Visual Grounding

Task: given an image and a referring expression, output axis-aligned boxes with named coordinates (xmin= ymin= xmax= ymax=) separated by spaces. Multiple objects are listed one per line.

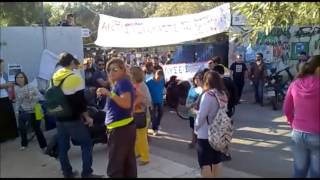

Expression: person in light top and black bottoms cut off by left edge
xmin=0 ymin=59 xmax=18 ymax=143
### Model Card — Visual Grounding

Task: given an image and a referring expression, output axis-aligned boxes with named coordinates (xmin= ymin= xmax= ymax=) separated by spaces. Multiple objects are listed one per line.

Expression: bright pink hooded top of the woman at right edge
xmin=283 ymin=76 xmax=320 ymax=134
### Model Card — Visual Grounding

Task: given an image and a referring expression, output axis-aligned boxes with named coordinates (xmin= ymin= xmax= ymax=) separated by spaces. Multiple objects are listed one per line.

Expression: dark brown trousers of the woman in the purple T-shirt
xmin=107 ymin=122 xmax=137 ymax=178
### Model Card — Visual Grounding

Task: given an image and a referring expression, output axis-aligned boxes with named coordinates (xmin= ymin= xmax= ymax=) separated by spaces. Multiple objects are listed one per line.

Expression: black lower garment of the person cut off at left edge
xmin=0 ymin=97 xmax=18 ymax=142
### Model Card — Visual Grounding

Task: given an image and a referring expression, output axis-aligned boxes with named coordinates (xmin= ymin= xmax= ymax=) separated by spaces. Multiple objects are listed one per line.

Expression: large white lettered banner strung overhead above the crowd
xmin=95 ymin=3 xmax=231 ymax=48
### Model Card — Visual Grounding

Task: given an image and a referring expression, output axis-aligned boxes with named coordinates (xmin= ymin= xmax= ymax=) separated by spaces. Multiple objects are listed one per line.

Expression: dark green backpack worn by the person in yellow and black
xmin=45 ymin=73 xmax=73 ymax=118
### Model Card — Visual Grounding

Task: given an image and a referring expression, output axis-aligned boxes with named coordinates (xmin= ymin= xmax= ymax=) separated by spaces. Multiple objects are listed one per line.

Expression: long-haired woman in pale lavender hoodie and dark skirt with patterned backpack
xmin=194 ymin=70 xmax=228 ymax=178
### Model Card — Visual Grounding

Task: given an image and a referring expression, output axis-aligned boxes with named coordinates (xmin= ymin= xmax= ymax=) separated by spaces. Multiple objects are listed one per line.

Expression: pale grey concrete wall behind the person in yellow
xmin=0 ymin=26 xmax=83 ymax=81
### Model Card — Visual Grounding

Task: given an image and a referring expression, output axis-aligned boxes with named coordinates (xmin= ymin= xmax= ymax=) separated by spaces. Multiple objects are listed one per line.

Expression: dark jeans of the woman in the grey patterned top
xmin=19 ymin=111 xmax=47 ymax=148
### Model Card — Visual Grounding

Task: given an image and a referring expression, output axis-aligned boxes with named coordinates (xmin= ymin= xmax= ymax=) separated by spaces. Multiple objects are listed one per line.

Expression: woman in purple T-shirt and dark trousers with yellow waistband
xmin=97 ymin=58 xmax=137 ymax=178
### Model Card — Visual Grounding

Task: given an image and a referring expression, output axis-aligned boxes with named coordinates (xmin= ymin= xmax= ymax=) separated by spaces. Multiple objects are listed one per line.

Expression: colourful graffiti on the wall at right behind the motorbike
xmin=229 ymin=26 xmax=320 ymax=68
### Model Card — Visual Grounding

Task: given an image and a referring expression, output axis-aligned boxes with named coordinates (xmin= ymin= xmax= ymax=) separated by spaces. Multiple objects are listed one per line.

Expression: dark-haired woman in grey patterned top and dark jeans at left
xmin=15 ymin=72 xmax=47 ymax=152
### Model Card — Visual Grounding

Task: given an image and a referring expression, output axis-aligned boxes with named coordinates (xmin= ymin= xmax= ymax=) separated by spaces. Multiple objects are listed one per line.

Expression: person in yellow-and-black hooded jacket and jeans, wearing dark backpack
xmin=52 ymin=52 xmax=102 ymax=178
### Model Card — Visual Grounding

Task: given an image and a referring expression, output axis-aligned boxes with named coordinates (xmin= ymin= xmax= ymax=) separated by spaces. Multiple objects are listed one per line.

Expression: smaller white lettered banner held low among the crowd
xmin=162 ymin=62 xmax=208 ymax=81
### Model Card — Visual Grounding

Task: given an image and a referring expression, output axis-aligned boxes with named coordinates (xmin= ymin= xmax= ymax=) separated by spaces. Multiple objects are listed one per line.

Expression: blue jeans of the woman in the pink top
xmin=292 ymin=130 xmax=320 ymax=178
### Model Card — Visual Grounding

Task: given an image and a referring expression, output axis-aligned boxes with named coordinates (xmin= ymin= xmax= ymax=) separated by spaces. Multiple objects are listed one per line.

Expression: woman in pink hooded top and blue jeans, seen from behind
xmin=283 ymin=55 xmax=320 ymax=178
